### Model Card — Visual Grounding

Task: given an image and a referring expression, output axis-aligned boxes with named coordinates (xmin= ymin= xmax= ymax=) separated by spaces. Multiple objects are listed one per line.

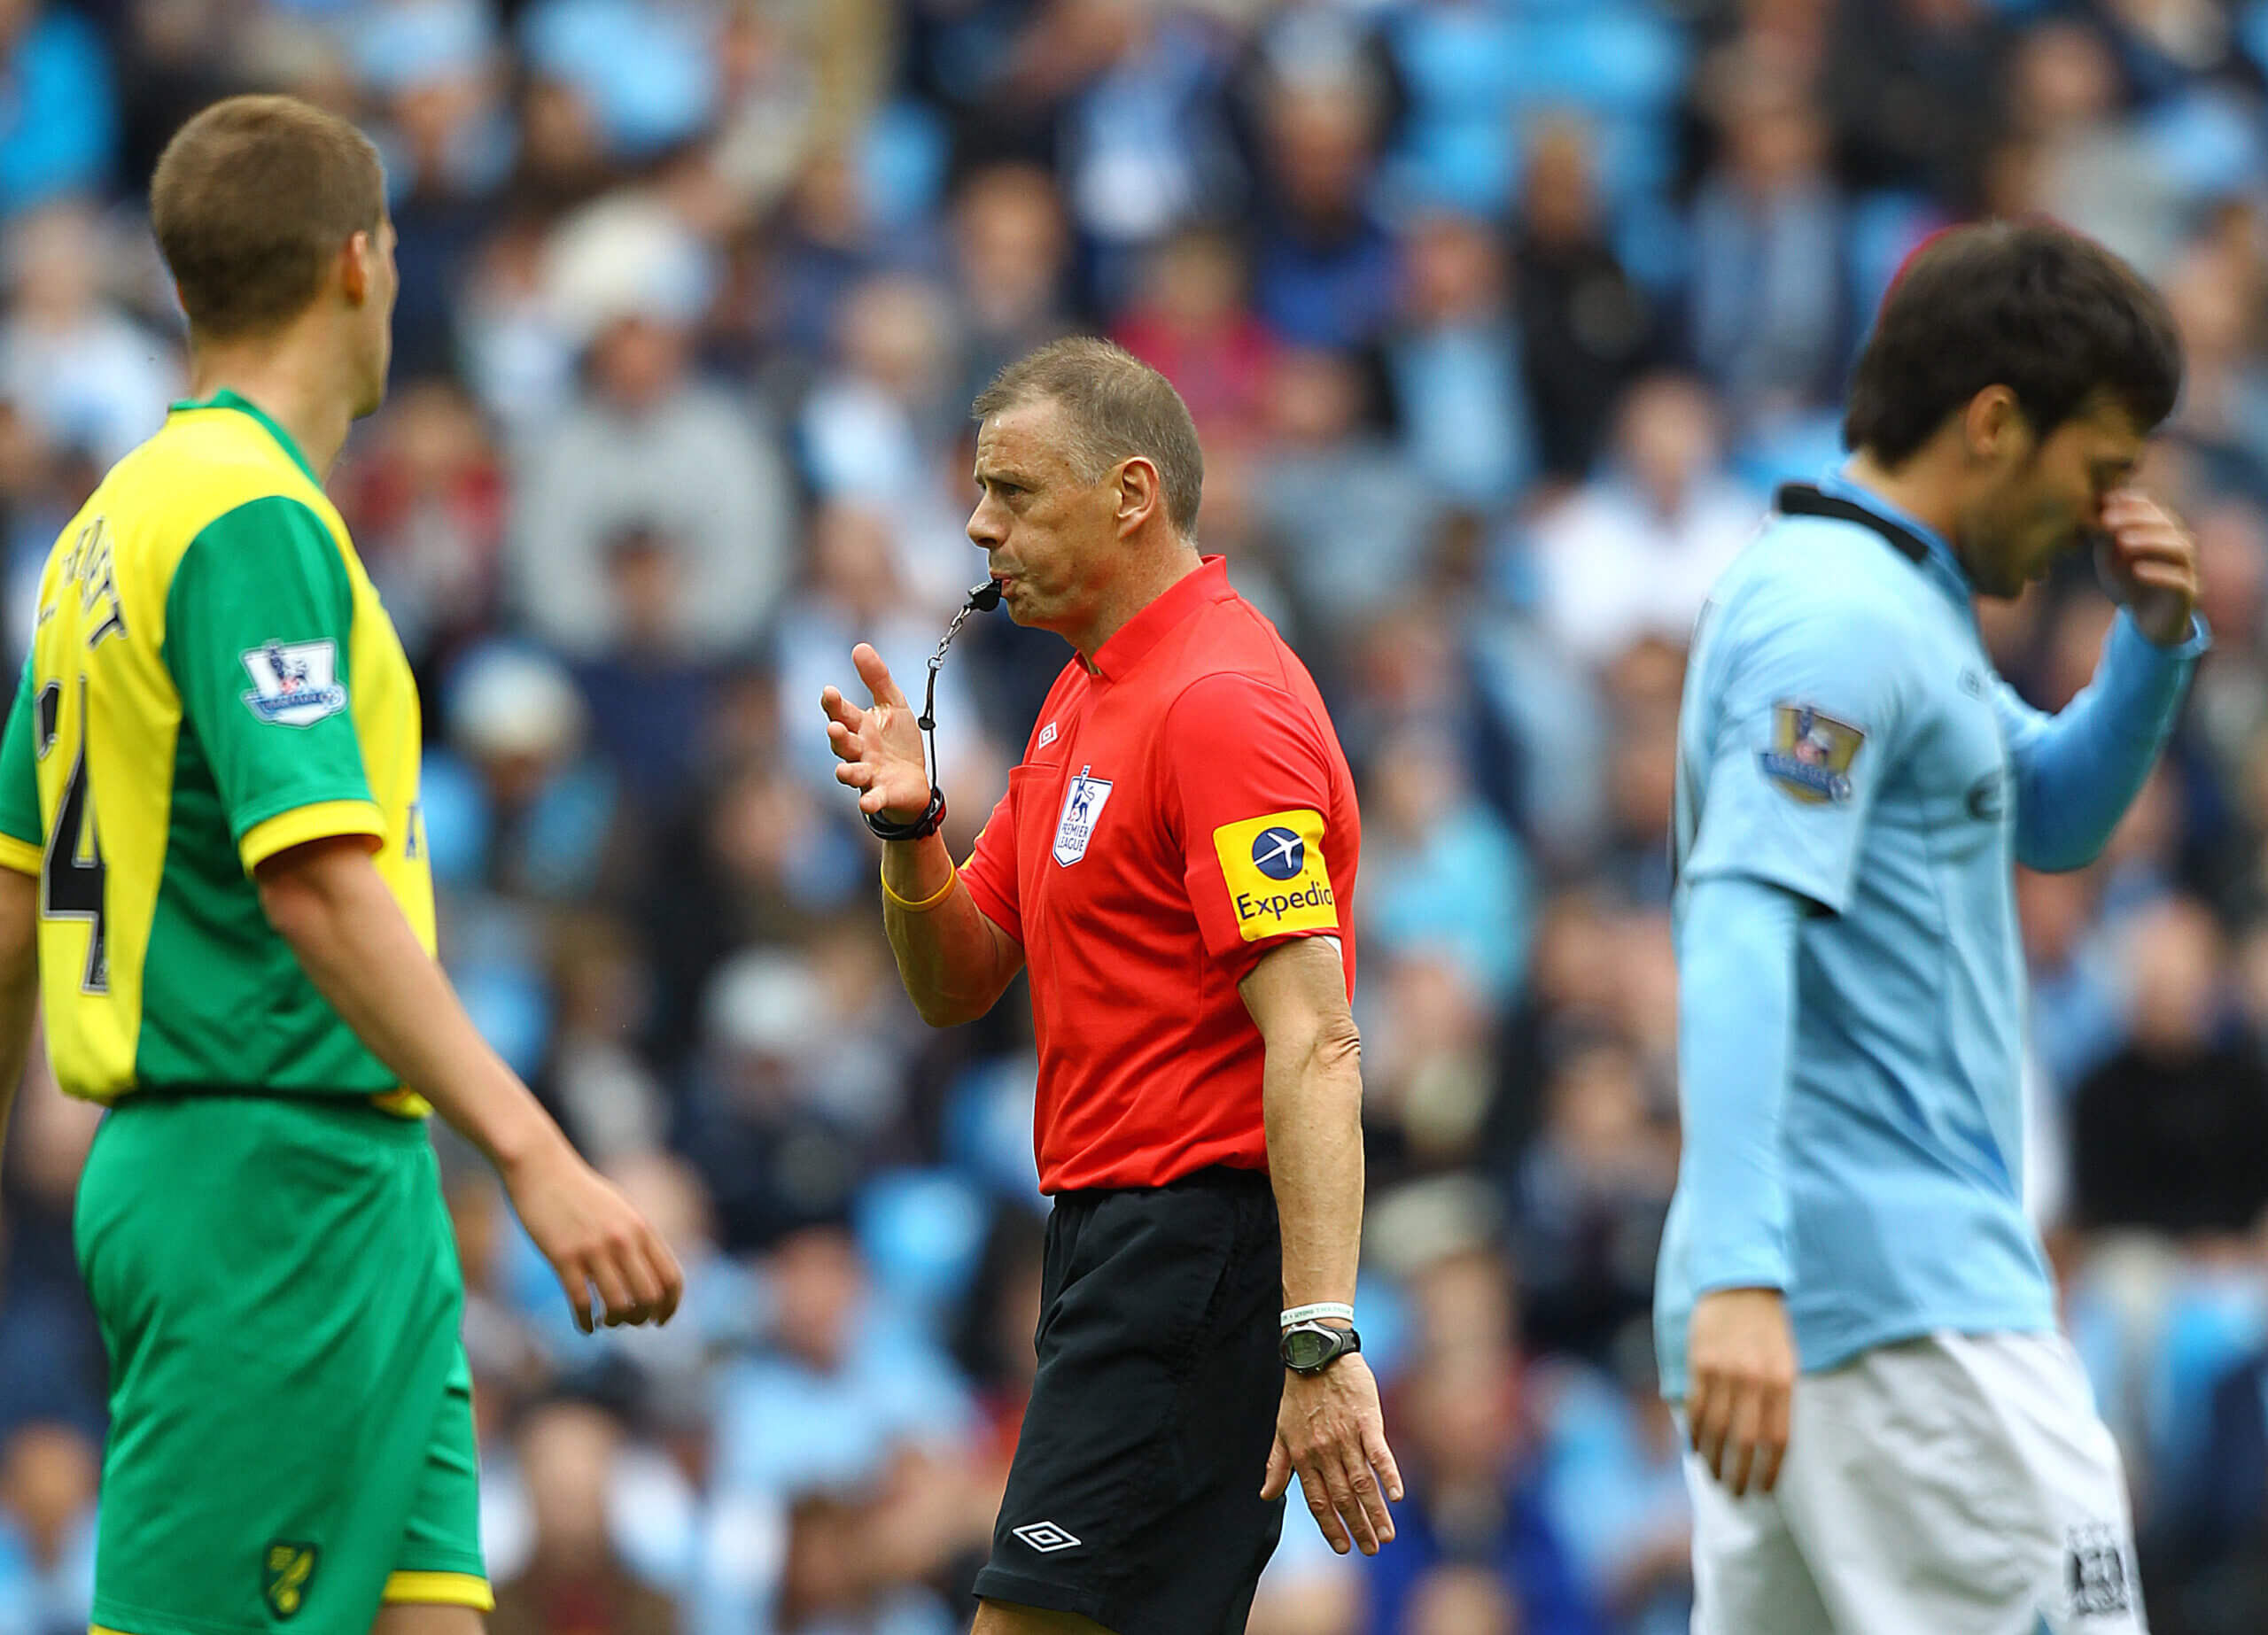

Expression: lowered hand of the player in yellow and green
xmin=503 ymin=1138 xmax=685 ymax=1333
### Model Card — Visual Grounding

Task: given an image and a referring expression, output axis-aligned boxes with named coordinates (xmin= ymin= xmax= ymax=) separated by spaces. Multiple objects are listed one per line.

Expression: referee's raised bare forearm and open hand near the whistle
xmin=819 ymin=642 xmax=1023 ymax=1027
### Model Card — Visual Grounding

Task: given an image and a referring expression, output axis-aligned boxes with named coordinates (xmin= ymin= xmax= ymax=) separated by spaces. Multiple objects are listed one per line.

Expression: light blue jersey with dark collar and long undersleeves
xmin=1656 ymin=477 xmax=2204 ymax=1399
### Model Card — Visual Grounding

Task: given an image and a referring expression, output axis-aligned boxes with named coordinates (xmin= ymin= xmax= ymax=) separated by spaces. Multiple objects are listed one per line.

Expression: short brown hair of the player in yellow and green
xmin=150 ymin=96 xmax=385 ymax=340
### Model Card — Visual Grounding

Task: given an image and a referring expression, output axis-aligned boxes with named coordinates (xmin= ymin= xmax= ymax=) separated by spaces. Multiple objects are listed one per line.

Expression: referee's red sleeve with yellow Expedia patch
xmin=1159 ymin=673 xmax=1354 ymax=966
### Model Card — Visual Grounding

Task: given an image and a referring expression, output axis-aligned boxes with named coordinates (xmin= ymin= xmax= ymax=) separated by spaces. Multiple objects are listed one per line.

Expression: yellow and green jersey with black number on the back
xmin=0 ymin=392 xmax=433 ymax=1113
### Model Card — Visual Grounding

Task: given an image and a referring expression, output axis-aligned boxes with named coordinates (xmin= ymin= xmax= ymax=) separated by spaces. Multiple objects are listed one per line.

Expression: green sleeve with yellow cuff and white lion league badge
xmin=166 ymin=497 xmax=385 ymax=871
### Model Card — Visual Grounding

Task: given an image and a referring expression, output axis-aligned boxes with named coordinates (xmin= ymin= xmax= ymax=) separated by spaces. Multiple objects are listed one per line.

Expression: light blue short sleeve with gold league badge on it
xmin=1683 ymin=603 xmax=1903 ymax=914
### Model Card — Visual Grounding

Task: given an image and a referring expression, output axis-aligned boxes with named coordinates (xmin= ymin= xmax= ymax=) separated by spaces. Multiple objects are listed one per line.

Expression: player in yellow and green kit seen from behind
xmin=0 ymin=97 xmax=683 ymax=1635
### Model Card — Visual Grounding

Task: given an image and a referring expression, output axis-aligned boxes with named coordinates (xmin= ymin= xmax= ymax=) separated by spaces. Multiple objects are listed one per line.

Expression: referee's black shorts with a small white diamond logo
xmin=975 ymin=1170 xmax=1284 ymax=1635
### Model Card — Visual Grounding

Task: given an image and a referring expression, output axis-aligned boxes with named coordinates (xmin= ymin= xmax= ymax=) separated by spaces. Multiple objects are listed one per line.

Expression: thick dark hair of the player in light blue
xmin=1844 ymin=222 xmax=2182 ymax=467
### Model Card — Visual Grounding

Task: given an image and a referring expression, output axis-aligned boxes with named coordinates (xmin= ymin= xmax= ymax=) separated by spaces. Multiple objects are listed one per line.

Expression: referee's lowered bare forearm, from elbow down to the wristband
xmin=1261 ymin=1025 xmax=1363 ymax=1306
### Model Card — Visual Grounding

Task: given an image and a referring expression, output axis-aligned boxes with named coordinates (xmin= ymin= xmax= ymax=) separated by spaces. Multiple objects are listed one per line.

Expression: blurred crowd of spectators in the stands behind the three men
xmin=0 ymin=0 xmax=2268 ymax=1635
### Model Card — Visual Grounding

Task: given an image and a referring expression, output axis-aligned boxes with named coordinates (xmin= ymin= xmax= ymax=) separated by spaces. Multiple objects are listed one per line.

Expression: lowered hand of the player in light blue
xmin=1685 ymin=1288 xmax=1797 ymax=1499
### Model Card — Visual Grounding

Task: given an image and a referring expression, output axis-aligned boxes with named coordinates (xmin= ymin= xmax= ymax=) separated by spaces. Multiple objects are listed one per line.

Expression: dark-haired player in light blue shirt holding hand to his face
xmin=1656 ymin=224 xmax=2204 ymax=1635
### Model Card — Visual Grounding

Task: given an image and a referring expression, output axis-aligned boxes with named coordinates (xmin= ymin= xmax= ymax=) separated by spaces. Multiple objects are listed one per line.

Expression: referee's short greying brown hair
xmin=971 ymin=336 xmax=1204 ymax=538
